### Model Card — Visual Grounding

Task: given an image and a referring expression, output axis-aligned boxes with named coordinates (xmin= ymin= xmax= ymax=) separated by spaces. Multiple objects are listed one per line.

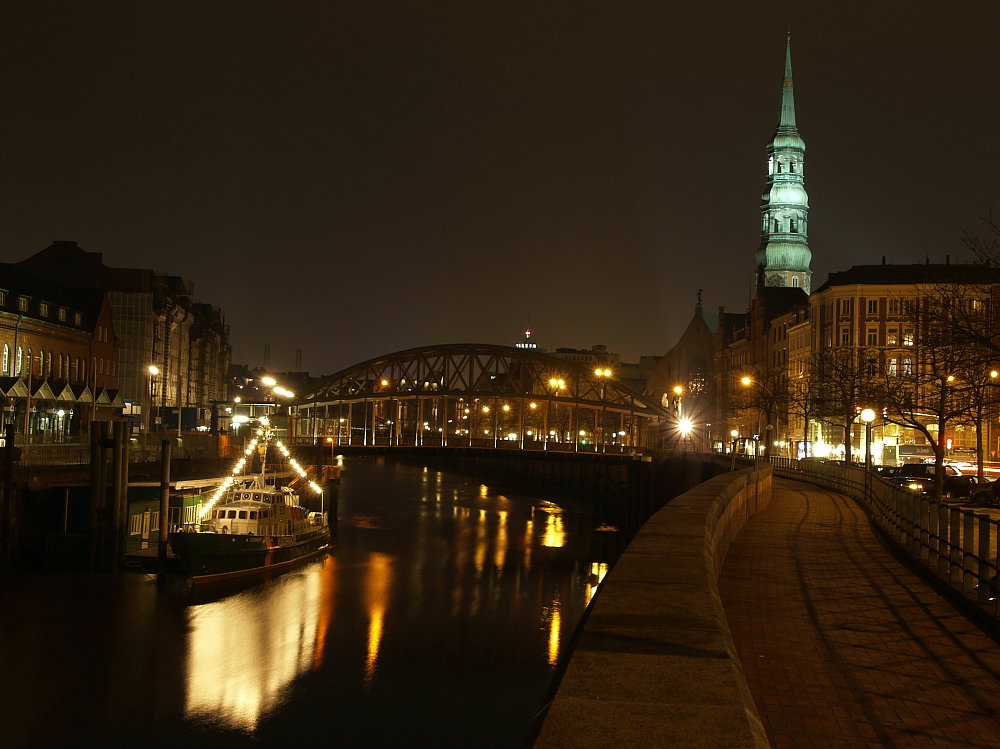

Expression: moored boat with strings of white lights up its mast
xmin=170 ymin=421 xmax=330 ymax=583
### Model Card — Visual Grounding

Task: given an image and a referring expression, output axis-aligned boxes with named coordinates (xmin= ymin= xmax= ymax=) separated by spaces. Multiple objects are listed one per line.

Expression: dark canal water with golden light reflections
xmin=0 ymin=460 xmax=616 ymax=749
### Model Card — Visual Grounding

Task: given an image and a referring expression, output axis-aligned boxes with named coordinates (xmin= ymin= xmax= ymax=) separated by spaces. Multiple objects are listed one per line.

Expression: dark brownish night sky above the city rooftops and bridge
xmin=0 ymin=0 xmax=1000 ymax=374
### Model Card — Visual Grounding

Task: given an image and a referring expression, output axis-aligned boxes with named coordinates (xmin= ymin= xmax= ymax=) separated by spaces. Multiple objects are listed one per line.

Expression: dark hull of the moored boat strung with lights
xmin=170 ymin=528 xmax=330 ymax=584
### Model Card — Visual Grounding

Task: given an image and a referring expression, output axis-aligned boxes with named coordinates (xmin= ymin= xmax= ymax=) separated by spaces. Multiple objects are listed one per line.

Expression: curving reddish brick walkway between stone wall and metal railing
xmin=719 ymin=478 xmax=1000 ymax=749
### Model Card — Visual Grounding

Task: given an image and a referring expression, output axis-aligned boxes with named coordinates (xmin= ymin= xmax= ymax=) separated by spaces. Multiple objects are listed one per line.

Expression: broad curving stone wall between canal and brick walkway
xmin=534 ymin=465 xmax=772 ymax=749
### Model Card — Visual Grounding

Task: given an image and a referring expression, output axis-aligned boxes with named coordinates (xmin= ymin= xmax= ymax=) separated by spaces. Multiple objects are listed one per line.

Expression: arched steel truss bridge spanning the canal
xmin=288 ymin=343 xmax=668 ymax=452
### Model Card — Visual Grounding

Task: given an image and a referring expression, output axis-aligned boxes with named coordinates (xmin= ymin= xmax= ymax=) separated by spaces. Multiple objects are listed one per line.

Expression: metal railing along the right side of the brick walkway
xmin=772 ymin=458 xmax=1000 ymax=617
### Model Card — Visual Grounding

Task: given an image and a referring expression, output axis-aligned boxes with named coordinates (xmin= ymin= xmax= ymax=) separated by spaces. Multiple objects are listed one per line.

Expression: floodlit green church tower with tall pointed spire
xmin=756 ymin=36 xmax=812 ymax=294
